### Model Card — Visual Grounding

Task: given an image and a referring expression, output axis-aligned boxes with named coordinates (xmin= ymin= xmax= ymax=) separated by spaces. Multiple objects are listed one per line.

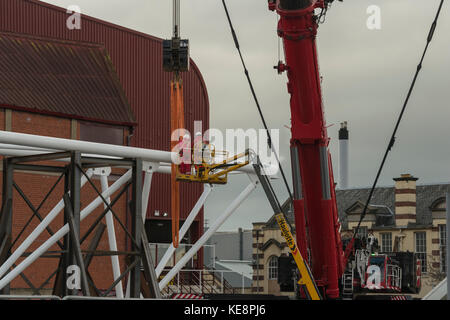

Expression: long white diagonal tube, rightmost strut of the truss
xmin=159 ymin=176 xmax=257 ymax=290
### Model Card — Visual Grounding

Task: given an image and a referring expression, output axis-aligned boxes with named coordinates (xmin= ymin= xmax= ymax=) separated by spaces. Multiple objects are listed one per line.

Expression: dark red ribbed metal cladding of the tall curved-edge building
xmin=0 ymin=0 xmax=209 ymax=227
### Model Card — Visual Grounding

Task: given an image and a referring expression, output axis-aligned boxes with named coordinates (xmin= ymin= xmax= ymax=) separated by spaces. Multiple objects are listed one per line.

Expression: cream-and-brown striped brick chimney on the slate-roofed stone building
xmin=394 ymin=174 xmax=418 ymax=226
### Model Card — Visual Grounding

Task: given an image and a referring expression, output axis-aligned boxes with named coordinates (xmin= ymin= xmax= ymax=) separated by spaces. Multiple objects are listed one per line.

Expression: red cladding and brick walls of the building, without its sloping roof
xmin=0 ymin=0 xmax=209 ymax=288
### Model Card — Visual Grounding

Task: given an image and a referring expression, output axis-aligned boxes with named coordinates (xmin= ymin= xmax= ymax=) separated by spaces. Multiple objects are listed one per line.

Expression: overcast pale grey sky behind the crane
xmin=45 ymin=0 xmax=450 ymax=230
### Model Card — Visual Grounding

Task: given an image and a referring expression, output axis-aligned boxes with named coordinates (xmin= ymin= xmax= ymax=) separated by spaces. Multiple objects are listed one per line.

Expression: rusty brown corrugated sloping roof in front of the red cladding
xmin=0 ymin=32 xmax=135 ymax=126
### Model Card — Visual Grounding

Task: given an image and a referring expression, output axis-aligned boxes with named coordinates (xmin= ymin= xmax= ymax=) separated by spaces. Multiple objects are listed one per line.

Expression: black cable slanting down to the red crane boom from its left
xmin=222 ymin=0 xmax=293 ymax=201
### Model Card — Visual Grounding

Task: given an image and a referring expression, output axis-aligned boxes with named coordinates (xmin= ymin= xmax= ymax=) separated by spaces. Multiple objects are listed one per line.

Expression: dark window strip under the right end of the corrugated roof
xmin=80 ymin=122 xmax=124 ymax=145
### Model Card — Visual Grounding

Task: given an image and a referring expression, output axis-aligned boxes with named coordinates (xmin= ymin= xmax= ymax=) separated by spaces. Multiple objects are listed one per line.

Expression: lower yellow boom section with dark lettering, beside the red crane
xmin=275 ymin=213 xmax=322 ymax=300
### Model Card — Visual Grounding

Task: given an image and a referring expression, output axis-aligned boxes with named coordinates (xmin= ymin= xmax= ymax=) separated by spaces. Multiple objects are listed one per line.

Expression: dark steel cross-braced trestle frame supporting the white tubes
xmin=0 ymin=151 xmax=159 ymax=298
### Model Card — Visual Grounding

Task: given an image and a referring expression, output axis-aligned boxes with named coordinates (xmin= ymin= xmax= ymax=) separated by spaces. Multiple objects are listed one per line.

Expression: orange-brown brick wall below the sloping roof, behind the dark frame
xmin=0 ymin=109 xmax=130 ymax=293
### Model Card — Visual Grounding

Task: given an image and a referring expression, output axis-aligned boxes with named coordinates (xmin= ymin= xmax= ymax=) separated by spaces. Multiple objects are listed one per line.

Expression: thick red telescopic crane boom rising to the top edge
xmin=269 ymin=0 xmax=344 ymax=298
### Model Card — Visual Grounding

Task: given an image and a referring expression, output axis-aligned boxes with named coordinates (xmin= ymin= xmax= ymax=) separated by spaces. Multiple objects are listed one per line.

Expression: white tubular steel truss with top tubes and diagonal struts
xmin=0 ymin=131 xmax=274 ymax=298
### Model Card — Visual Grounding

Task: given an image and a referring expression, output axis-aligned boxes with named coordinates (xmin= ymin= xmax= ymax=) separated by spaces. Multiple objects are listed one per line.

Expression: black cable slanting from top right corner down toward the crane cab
xmin=353 ymin=0 xmax=444 ymax=238
